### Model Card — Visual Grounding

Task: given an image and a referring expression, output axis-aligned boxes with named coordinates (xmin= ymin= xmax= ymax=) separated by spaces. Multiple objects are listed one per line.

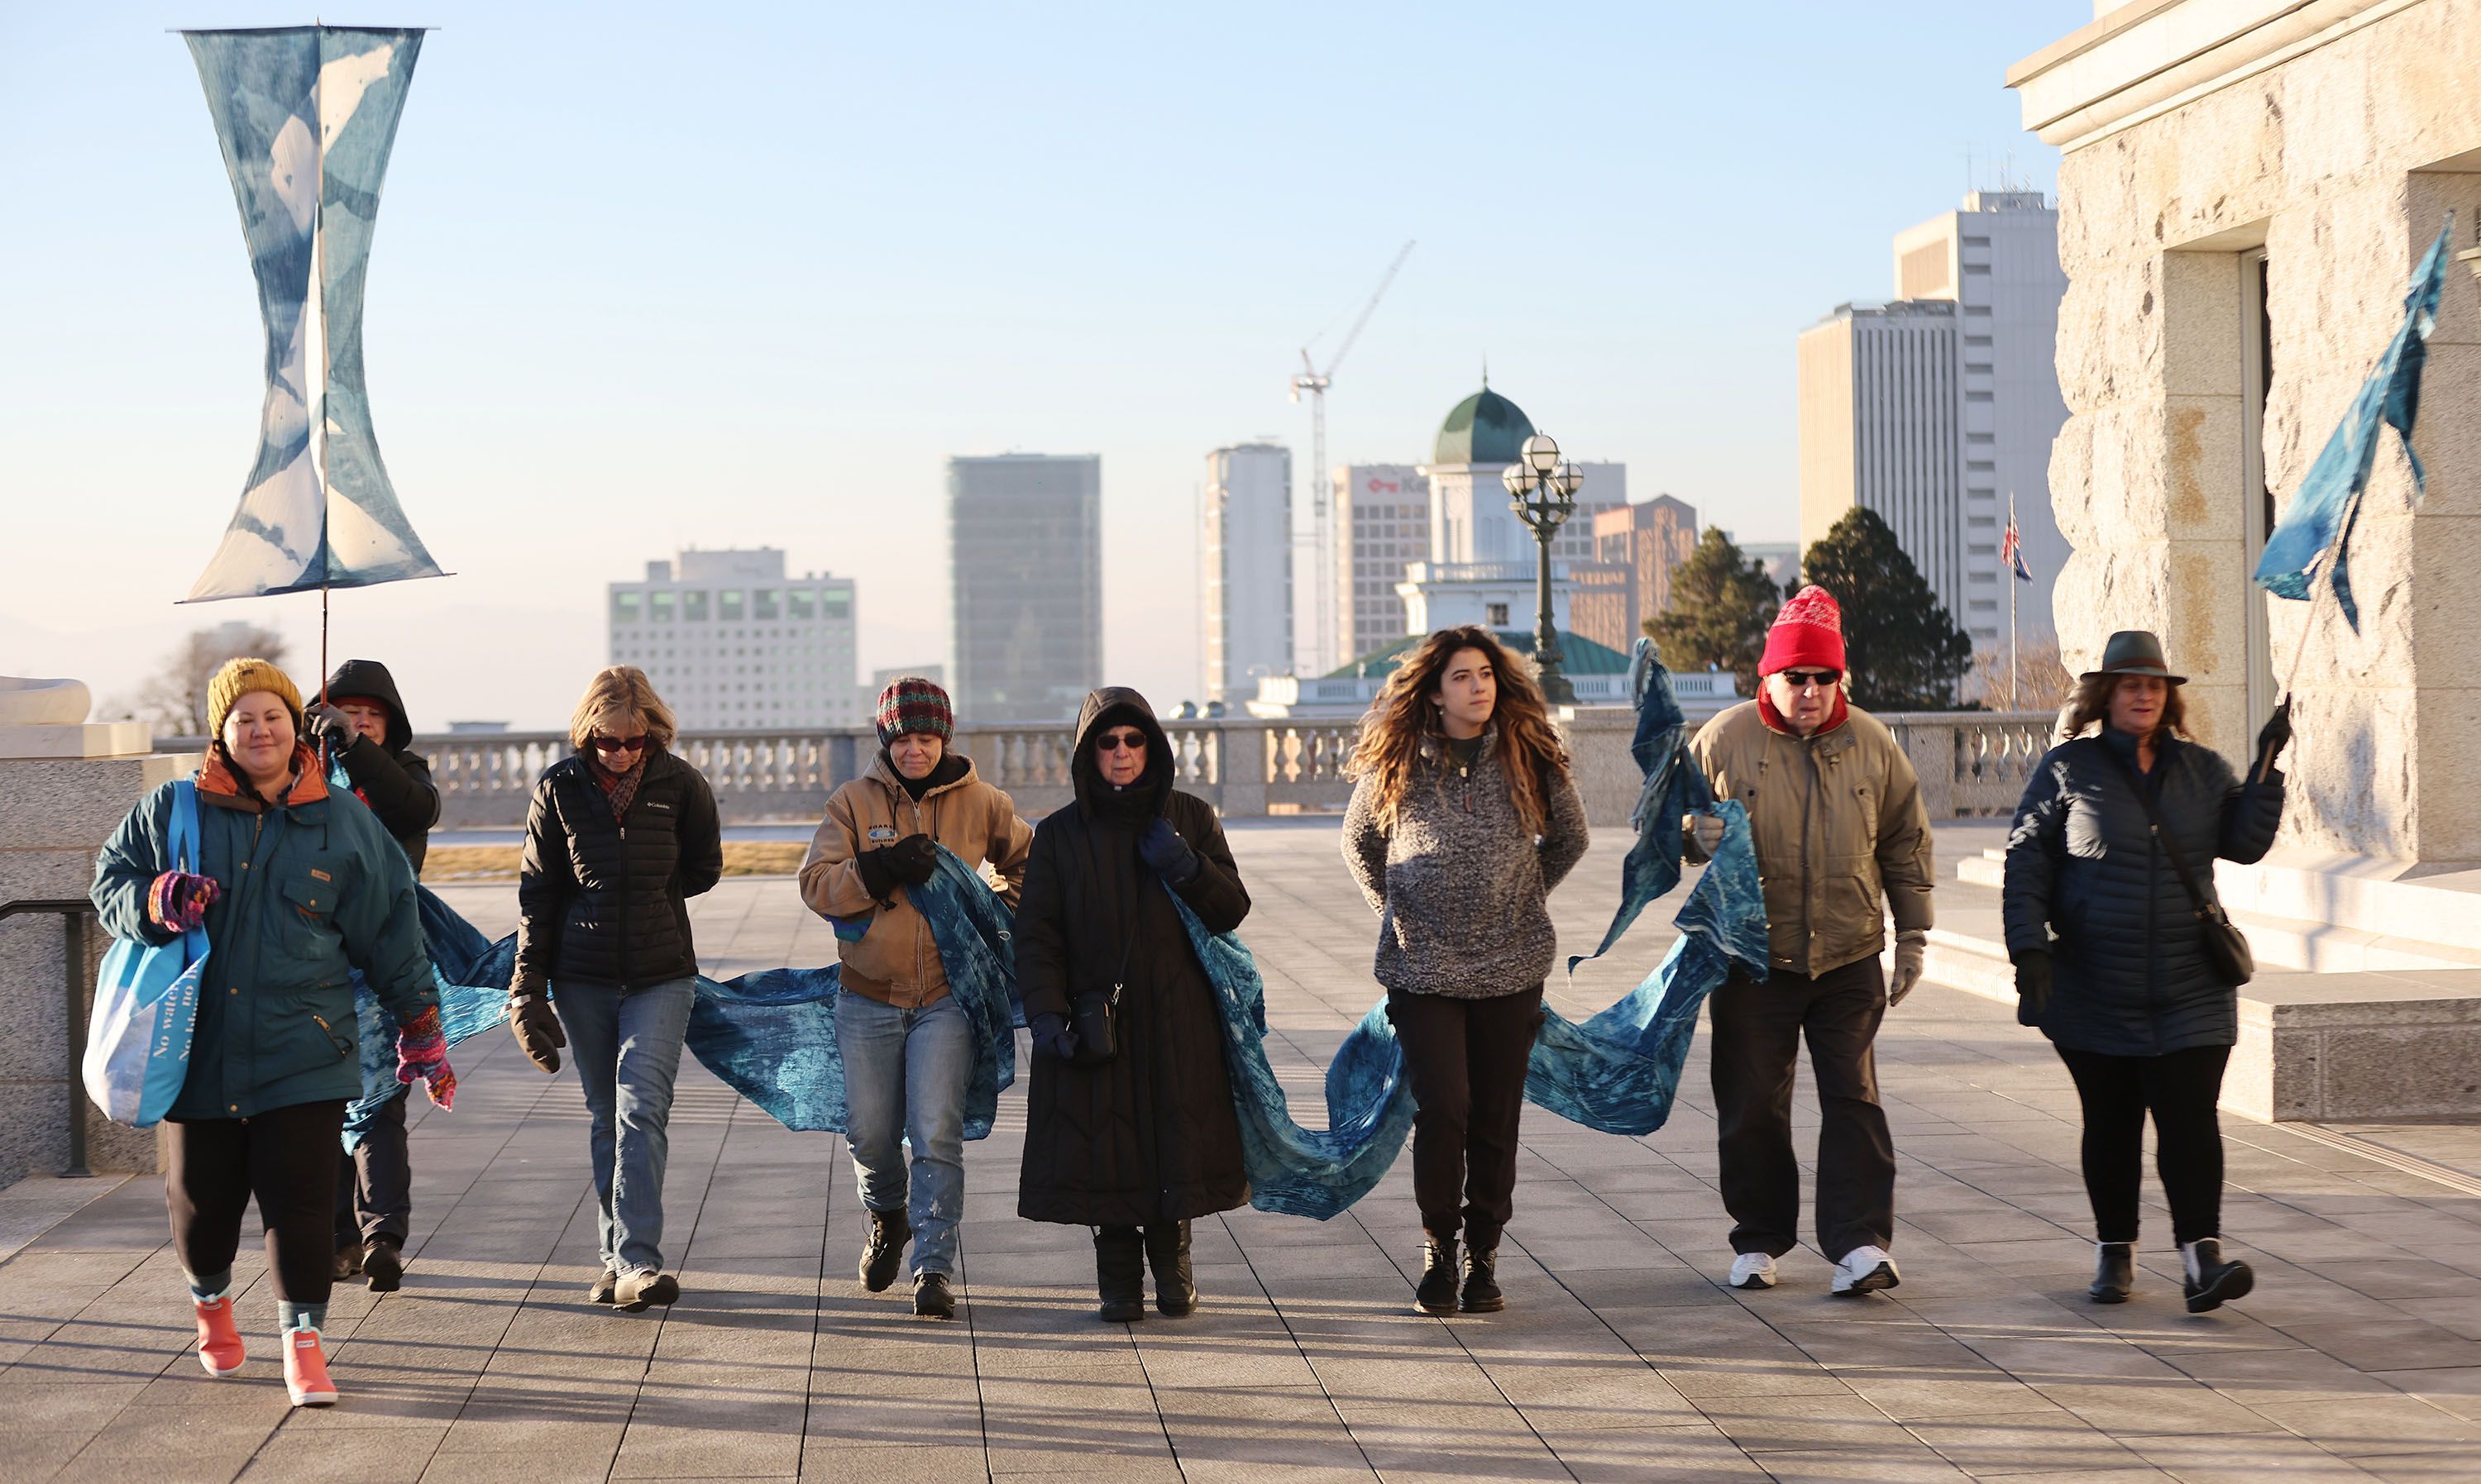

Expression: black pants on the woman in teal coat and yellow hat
xmin=164 ymin=1102 xmax=345 ymax=1303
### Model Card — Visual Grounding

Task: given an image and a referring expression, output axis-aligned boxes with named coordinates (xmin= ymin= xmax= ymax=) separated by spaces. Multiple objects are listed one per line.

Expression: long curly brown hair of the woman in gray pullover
xmin=1345 ymin=625 xmax=1568 ymax=834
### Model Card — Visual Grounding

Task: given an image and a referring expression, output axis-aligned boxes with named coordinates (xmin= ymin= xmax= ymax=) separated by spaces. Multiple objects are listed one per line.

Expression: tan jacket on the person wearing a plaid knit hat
xmin=801 ymin=752 xmax=1035 ymax=1010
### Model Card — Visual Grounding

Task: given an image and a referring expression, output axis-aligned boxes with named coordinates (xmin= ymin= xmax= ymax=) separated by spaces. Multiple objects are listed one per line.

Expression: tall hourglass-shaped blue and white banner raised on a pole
xmin=181 ymin=25 xmax=442 ymax=603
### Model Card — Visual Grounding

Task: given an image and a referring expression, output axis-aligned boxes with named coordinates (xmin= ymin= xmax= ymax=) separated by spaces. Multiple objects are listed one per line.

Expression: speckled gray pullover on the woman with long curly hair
xmin=1345 ymin=727 xmax=1585 ymax=1000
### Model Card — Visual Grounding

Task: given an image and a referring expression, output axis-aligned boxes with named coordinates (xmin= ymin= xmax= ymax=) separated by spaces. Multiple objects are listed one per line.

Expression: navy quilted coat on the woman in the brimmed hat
xmin=2005 ymin=727 xmax=2283 ymax=1057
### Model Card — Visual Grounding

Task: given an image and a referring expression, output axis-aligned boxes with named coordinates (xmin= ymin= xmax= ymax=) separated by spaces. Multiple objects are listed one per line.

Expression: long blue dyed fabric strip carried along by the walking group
xmin=347 ymin=640 xmax=1766 ymax=1221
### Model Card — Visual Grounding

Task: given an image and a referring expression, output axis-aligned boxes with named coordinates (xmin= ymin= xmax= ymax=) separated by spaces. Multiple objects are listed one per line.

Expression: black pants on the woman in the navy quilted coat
xmin=2059 ymin=1047 xmax=2230 ymax=1243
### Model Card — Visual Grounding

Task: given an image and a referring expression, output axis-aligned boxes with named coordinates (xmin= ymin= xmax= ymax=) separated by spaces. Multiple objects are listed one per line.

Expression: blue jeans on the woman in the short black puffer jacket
xmin=551 ymin=981 xmax=697 ymax=1273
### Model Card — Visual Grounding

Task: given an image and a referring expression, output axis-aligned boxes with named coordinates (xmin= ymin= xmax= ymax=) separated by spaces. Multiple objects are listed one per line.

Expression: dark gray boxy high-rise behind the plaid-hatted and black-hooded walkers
xmin=948 ymin=454 xmax=1102 ymax=722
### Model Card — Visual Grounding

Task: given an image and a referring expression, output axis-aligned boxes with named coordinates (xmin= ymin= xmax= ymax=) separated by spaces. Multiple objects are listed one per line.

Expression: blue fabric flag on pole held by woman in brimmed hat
xmin=2258 ymin=213 xmax=2456 ymax=632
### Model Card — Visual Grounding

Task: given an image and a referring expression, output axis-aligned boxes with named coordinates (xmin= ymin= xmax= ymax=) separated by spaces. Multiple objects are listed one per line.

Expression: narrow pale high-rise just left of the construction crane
xmin=1198 ymin=444 xmax=1293 ymax=702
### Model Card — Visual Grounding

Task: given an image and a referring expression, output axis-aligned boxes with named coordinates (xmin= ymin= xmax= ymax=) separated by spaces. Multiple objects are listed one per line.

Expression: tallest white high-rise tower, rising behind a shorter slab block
xmin=1895 ymin=191 xmax=2067 ymax=640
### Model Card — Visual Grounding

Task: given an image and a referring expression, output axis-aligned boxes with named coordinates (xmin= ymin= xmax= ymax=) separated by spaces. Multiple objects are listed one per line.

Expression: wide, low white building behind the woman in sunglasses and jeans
xmin=608 ymin=546 xmax=863 ymax=732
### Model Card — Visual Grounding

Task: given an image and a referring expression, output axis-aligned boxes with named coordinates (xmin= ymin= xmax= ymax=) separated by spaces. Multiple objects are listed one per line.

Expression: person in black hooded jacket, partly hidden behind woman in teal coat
xmin=303 ymin=660 xmax=439 ymax=1293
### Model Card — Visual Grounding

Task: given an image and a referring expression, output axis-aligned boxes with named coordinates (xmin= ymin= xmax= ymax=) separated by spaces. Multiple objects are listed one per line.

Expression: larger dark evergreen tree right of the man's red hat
xmin=1801 ymin=506 xmax=1972 ymax=712
